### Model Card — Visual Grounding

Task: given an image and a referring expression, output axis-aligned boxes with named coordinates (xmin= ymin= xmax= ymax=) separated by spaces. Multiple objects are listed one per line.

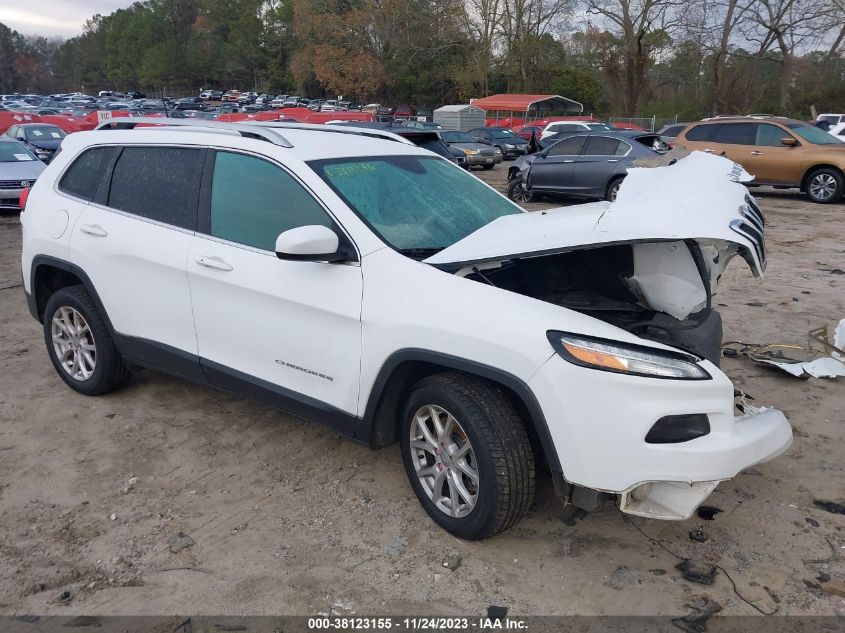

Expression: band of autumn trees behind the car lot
xmin=0 ymin=0 xmax=845 ymax=119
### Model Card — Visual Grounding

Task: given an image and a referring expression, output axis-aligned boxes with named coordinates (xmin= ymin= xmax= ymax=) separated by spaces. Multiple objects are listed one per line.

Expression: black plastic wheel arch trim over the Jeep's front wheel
xmin=356 ymin=349 xmax=563 ymax=473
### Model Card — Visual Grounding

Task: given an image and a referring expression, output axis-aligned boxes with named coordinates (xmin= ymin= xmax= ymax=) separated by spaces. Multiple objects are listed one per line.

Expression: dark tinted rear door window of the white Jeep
xmin=108 ymin=147 xmax=204 ymax=231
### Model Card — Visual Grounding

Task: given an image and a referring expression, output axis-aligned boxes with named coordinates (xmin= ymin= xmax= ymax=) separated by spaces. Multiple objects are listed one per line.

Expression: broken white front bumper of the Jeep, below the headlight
xmin=530 ymin=356 xmax=792 ymax=519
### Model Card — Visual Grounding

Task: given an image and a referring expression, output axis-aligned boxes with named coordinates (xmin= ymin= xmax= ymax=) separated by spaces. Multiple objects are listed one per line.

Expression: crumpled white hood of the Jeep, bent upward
xmin=424 ymin=152 xmax=765 ymax=276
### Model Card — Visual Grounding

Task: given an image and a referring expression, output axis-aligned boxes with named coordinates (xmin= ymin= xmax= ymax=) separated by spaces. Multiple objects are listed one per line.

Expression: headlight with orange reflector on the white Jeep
xmin=546 ymin=330 xmax=711 ymax=380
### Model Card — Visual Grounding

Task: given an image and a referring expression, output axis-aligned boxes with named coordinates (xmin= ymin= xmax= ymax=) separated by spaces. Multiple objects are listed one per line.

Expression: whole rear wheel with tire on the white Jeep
xmin=44 ymin=286 xmax=132 ymax=396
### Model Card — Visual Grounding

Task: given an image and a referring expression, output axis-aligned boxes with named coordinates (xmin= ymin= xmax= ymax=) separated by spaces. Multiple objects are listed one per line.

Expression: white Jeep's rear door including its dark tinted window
xmin=70 ymin=146 xmax=205 ymax=364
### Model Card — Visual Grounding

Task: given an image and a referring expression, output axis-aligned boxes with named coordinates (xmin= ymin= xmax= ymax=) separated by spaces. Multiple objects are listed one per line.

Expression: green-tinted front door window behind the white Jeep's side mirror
xmin=211 ymin=152 xmax=333 ymax=251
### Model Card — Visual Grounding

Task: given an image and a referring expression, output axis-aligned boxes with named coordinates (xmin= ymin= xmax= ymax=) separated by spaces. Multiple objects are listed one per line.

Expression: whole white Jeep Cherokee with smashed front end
xmin=21 ymin=119 xmax=792 ymax=539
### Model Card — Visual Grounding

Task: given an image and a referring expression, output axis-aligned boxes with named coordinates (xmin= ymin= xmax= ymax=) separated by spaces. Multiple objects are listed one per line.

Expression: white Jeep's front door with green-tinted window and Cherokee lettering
xmin=188 ymin=151 xmax=363 ymax=434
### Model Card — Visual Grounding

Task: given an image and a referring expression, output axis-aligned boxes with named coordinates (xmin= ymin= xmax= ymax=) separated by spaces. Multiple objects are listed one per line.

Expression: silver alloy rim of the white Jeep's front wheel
xmin=409 ymin=404 xmax=479 ymax=518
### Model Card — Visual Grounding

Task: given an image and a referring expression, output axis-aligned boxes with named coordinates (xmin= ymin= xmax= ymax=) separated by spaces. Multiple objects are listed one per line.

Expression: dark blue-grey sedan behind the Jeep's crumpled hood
xmin=508 ymin=131 xmax=662 ymax=202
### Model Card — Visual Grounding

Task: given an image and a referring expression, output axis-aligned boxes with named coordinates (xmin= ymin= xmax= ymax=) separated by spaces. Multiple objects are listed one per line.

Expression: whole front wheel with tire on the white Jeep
xmin=401 ymin=372 xmax=535 ymax=541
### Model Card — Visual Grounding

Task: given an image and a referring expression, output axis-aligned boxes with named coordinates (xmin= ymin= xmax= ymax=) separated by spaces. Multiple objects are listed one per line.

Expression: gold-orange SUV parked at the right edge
xmin=675 ymin=116 xmax=845 ymax=203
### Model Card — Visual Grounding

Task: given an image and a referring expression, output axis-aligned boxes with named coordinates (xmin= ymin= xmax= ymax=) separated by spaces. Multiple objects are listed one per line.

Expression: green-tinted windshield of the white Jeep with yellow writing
xmin=309 ymin=156 xmax=522 ymax=252
